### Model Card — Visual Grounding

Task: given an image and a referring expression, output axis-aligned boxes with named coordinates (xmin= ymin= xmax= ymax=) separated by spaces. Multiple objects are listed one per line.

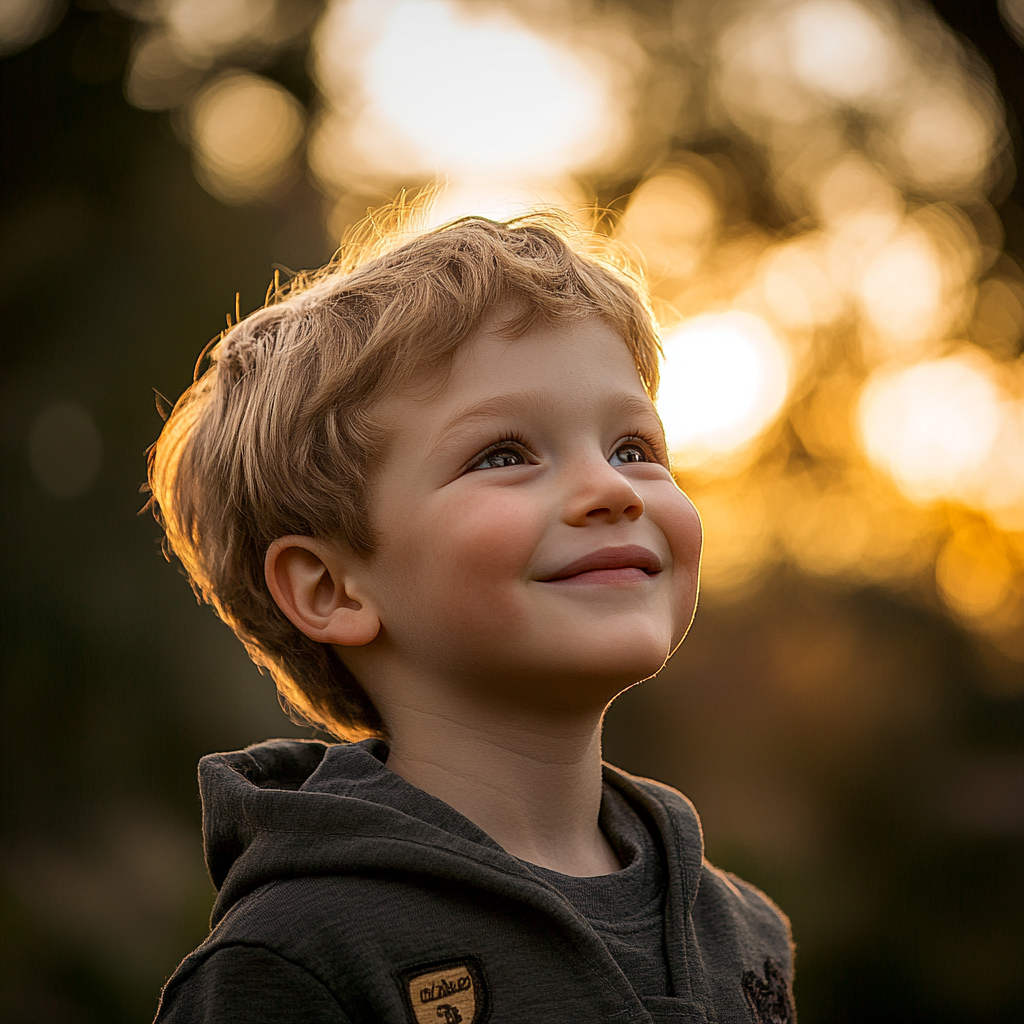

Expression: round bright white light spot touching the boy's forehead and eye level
xmin=657 ymin=312 xmax=788 ymax=468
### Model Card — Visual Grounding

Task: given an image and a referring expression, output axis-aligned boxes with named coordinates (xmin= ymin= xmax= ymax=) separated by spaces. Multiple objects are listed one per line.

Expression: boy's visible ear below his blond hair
xmin=263 ymin=537 xmax=381 ymax=647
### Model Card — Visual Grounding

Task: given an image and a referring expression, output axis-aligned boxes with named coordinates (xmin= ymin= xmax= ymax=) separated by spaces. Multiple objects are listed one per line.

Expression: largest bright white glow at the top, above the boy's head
xmin=316 ymin=0 xmax=622 ymax=188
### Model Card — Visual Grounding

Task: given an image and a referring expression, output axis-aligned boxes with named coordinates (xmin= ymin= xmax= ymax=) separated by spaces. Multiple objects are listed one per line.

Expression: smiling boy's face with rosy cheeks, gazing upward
xmin=341 ymin=310 xmax=700 ymax=711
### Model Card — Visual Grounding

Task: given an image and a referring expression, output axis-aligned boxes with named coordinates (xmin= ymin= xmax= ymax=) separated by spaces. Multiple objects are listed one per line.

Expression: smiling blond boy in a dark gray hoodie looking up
xmin=150 ymin=214 xmax=796 ymax=1024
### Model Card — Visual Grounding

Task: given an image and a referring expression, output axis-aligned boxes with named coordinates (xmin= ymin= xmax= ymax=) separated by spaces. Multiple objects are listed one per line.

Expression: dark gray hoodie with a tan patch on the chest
xmin=151 ymin=740 xmax=796 ymax=1024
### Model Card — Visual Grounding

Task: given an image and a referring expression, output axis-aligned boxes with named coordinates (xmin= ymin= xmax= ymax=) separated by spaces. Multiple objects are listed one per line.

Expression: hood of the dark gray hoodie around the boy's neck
xmin=199 ymin=739 xmax=703 ymax=925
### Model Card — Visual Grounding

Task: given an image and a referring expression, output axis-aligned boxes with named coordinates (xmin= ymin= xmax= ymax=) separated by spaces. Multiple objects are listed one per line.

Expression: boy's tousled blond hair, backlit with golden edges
xmin=148 ymin=203 xmax=659 ymax=739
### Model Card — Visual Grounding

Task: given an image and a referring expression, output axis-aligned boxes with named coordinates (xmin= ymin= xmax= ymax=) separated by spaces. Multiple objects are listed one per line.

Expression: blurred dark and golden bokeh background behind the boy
xmin=0 ymin=0 xmax=1024 ymax=1024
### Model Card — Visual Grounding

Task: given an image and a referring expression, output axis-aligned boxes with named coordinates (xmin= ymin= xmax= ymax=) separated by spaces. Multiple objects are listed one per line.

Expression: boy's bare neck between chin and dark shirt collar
xmin=387 ymin=706 xmax=621 ymax=876
